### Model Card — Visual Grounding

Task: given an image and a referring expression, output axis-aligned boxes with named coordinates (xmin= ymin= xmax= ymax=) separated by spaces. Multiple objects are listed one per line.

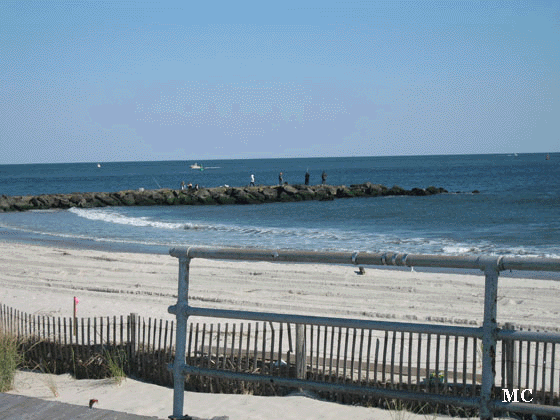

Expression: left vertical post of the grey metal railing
xmin=169 ymin=257 xmax=191 ymax=420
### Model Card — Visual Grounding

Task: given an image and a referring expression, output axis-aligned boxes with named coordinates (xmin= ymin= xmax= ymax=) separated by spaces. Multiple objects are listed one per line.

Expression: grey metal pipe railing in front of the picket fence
xmin=169 ymin=247 xmax=560 ymax=420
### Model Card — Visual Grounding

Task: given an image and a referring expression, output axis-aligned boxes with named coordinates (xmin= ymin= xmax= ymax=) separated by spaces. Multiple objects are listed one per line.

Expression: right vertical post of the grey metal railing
xmin=480 ymin=259 xmax=499 ymax=420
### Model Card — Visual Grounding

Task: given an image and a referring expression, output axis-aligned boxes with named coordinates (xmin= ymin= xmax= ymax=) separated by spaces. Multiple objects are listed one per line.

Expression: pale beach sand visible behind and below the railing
xmin=0 ymin=242 xmax=560 ymax=420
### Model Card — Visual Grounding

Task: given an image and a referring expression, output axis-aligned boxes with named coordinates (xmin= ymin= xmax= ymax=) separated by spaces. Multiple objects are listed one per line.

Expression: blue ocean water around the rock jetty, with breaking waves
xmin=0 ymin=153 xmax=560 ymax=257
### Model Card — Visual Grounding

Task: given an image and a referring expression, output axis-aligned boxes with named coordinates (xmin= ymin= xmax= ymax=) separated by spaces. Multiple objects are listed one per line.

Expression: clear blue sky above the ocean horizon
xmin=0 ymin=0 xmax=560 ymax=164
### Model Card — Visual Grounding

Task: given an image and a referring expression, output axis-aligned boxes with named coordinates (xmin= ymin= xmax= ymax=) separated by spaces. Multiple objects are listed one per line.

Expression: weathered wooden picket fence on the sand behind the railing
xmin=0 ymin=305 xmax=560 ymax=405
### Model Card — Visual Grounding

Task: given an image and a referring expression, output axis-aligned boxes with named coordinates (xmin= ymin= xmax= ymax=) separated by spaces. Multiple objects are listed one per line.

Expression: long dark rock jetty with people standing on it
xmin=0 ymin=182 xmax=447 ymax=212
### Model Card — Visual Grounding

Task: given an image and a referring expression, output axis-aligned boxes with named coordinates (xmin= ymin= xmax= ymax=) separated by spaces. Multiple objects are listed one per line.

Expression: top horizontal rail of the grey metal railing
xmin=169 ymin=246 xmax=560 ymax=271
